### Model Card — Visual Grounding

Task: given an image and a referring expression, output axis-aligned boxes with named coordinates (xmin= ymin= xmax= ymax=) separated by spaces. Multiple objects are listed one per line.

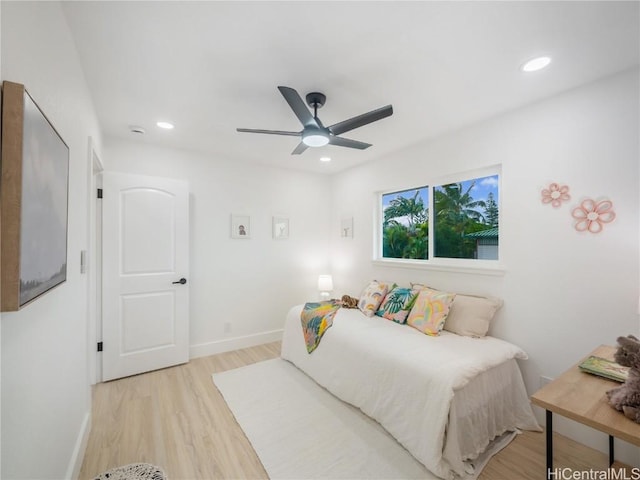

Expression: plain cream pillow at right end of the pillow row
xmin=444 ymin=294 xmax=503 ymax=337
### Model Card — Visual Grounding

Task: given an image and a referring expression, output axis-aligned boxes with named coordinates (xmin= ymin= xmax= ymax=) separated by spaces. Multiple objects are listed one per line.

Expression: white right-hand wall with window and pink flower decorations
xmin=332 ymin=71 xmax=640 ymax=465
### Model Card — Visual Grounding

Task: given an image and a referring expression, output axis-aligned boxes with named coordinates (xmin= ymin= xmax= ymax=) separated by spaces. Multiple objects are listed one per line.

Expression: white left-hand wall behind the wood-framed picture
xmin=0 ymin=2 xmax=100 ymax=479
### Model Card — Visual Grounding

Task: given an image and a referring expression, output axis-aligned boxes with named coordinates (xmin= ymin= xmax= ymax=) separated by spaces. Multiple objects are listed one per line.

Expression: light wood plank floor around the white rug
xmin=80 ymin=342 xmax=607 ymax=480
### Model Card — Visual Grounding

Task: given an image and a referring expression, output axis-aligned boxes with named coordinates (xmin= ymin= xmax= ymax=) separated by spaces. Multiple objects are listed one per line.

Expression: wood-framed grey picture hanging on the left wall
xmin=0 ymin=81 xmax=69 ymax=312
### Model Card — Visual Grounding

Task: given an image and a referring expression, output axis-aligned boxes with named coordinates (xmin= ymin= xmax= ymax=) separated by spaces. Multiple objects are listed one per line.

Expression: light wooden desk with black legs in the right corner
xmin=531 ymin=345 xmax=640 ymax=478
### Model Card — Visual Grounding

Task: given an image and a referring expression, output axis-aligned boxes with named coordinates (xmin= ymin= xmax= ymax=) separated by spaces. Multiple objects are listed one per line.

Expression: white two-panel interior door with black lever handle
xmin=102 ymin=172 xmax=189 ymax=381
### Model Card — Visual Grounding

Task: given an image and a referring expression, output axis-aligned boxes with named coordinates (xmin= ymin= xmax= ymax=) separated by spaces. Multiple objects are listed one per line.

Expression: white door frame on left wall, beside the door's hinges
xmin=85 ymin=137 xmax=104 ymax=385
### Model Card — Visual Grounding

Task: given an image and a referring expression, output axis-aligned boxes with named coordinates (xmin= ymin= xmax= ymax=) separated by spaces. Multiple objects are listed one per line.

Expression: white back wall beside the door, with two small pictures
xmin=103 ymin=139 xmax=330 ymax=357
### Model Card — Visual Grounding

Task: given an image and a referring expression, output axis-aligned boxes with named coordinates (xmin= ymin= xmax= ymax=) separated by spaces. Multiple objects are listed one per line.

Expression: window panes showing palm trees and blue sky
xmin=379 ymin=169 xmax=500 ymax=264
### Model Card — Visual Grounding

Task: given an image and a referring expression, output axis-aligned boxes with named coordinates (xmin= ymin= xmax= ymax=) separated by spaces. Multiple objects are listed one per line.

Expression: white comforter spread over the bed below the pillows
xmin=281 ymin=305 xmax=538 ymax=478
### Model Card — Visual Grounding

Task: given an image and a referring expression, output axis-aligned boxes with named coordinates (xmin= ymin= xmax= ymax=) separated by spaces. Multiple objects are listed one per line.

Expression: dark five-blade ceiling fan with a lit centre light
xmin=236 ymin=87 xmax=393 ymax=155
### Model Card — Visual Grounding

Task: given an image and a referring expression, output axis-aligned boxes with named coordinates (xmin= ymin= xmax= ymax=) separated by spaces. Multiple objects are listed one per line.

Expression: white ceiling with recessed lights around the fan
xmin=63 ymin=1 xmax=640 ymax=173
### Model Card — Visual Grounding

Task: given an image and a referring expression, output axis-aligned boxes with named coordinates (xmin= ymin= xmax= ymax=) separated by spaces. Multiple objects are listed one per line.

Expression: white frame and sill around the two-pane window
xmin=372 ymin=165 xmax=505 ymax=275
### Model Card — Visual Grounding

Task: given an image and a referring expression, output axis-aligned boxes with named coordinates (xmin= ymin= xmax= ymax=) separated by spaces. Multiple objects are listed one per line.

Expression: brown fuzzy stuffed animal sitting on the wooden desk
xmin=607 ymin=335 xmax=640 ymax=423
